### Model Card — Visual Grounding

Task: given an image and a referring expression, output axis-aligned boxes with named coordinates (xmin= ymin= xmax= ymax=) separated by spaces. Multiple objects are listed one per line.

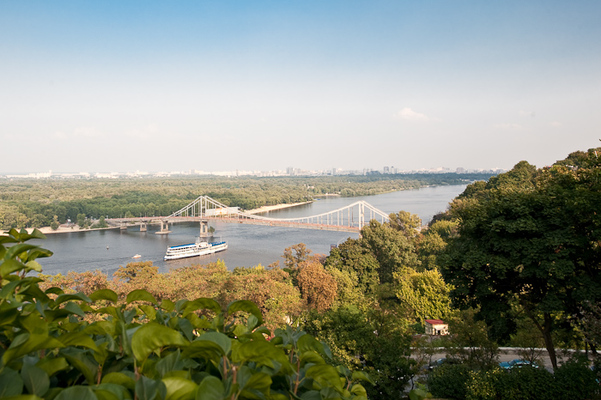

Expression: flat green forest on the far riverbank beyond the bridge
xmin=0 ymin=173 xmax=492 ymax=229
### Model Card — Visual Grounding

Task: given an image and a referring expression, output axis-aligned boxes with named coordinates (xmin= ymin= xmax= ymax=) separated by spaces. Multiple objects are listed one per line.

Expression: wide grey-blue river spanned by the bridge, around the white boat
xmin=38 ymin=185 xmax=465 ymax=275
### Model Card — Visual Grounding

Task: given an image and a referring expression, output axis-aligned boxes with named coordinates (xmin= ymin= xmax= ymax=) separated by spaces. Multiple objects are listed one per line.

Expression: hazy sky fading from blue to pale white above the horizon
xmin=0 ymin=0 xmax=601 ymax=174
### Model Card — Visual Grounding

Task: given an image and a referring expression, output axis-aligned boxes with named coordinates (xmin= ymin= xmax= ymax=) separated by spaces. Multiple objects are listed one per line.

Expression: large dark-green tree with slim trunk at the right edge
xmin=442 ymin=149 xmax=601 ymax=368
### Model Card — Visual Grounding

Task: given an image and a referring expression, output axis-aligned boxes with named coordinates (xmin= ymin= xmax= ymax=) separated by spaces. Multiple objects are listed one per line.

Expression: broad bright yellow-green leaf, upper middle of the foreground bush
xmin=131 ymin=322 xmax=188 ymax=362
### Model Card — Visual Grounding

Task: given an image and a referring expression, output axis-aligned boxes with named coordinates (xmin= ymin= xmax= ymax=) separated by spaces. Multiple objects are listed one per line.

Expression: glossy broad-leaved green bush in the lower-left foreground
xmin=0 ymin=229 xmax=369 ymax=400
